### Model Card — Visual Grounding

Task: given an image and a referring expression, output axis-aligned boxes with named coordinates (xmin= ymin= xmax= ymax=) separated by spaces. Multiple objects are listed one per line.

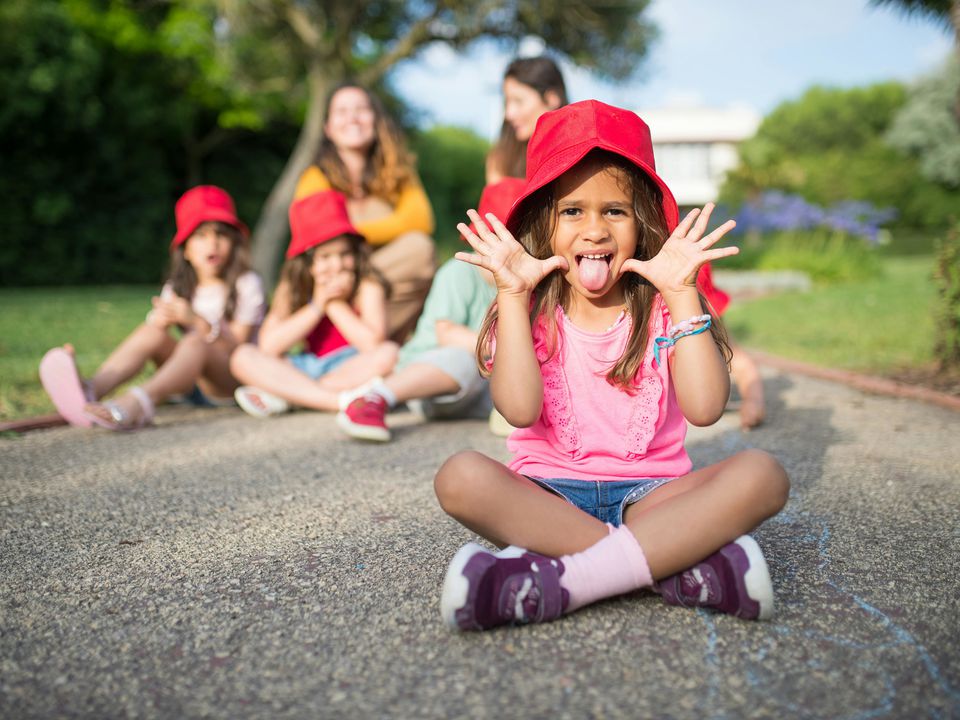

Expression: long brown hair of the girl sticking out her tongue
xmin=477 ymin=150 xmax=731 ymax=392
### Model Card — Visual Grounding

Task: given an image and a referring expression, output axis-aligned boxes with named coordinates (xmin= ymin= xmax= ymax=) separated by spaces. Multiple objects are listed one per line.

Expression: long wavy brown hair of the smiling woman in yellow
xmin=314 ymin=82 xmax=416 ymax=204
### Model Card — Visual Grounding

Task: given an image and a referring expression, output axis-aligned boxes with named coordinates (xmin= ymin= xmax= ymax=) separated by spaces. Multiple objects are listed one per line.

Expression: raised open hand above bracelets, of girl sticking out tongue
xmin=620 ymin=203 xmax=740 ymax=294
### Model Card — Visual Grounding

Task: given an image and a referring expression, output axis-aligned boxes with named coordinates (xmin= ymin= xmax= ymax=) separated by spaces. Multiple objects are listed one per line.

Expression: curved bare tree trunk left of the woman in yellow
xmin=252 ymin=66 xmax=336 ymax=288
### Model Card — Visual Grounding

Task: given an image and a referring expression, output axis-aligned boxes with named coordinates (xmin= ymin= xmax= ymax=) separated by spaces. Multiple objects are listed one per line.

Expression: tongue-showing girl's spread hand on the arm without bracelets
xmin=455 ymin=210 xmax=569 ymax=295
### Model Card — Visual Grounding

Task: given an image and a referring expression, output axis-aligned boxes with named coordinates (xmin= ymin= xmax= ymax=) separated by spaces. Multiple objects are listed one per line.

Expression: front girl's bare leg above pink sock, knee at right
xmin=624 ymin=450 xmax=790 ymax=579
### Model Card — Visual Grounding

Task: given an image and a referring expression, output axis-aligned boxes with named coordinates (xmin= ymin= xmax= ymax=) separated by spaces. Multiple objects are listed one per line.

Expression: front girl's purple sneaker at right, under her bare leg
xmin=657 ymin=535 xmax=773 ymax=620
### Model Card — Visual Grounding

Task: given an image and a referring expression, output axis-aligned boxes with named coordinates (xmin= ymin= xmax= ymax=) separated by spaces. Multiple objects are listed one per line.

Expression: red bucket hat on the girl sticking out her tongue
xmin=506 ymin=100 xmax=680 ymax=232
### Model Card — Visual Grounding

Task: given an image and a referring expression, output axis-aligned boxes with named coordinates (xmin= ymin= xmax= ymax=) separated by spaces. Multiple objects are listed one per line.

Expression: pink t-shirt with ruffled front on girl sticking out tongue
xmin=507 ymin=300 xmax=692 ymax=480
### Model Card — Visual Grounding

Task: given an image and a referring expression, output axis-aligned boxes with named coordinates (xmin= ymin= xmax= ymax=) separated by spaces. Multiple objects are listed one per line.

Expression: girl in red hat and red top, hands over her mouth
xmin=230 ymin=190 xmax=397 ymax=417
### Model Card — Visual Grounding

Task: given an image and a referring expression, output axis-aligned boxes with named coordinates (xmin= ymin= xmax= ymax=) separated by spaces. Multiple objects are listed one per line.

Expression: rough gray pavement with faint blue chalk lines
xmin=0 ymin=372 xmax=960 ymax=718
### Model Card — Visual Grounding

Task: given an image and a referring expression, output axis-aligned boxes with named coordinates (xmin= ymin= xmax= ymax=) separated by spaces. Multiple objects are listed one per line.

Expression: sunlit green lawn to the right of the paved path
xmin=725 ymin=256 xmax=934 ymax=374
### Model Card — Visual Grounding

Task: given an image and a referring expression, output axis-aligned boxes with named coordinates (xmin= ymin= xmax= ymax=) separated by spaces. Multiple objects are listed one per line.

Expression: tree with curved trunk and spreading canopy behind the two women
xmin=211 ymin=0 xmax=654 ymax=286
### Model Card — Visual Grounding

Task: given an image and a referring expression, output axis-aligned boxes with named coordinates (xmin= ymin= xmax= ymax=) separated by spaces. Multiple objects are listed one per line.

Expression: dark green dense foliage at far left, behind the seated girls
xmin=0 ymin=0 xmax=293 ymax=285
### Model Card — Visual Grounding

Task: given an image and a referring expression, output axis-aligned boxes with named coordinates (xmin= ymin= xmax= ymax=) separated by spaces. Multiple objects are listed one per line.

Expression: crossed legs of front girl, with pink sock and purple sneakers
xmin=435 ymin=450 xmax=789 ymax=629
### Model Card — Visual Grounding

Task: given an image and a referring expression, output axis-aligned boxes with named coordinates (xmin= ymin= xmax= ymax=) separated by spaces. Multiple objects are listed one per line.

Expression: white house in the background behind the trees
xmin=637 ymin=106 xmax=761 ymax=207
